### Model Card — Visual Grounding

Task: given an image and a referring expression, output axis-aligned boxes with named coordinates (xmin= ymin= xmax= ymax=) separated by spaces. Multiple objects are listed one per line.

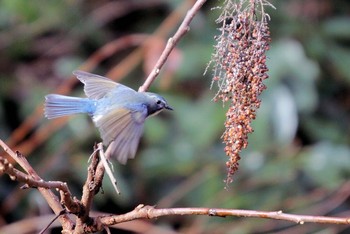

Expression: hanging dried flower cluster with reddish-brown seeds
xmin=211 ymin=0 xmax=270 ymax=186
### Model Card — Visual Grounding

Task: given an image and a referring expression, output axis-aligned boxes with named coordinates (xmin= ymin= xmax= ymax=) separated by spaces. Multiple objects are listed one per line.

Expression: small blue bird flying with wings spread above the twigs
xmin=45 ymin=71 xmax=173 ymax=164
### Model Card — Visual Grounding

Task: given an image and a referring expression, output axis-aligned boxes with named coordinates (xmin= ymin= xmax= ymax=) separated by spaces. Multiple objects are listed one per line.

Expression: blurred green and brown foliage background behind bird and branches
xmin=0 ymin=0 xmax=350 ymax=233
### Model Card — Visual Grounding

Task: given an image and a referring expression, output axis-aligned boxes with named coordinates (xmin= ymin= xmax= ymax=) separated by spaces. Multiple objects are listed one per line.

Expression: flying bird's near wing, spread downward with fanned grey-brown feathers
xmin=93 ymin=108 xmax=147 ymax=164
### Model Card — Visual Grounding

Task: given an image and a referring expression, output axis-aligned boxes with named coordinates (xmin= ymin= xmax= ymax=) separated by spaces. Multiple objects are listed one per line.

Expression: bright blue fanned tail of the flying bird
xmin=45 ymin=94 xmax=95 ymax=119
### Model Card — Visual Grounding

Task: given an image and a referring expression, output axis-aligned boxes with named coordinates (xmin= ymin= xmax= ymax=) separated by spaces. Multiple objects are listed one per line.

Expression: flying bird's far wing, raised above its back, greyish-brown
xmin=73 ymin=71 xmax=133 ymax=100
